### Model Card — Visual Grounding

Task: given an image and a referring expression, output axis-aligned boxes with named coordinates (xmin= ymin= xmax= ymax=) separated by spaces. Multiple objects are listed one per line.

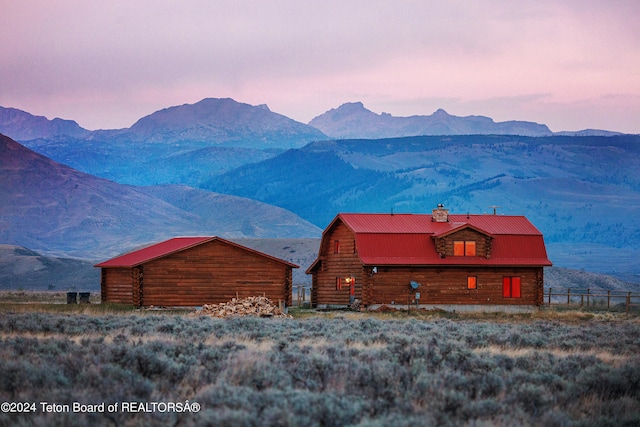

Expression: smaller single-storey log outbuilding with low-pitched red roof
xmin=96 ymin=237 xmax=299 ymax=306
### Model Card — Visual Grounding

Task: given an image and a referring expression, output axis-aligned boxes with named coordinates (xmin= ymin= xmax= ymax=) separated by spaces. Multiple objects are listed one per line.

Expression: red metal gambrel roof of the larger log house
xmin=307 ymin=213 xmax=551 ymax=272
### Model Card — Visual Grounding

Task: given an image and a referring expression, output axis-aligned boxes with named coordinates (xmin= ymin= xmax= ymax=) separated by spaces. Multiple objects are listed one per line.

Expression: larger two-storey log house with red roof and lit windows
xmin=306 ymin=205 xmax=551 ymax=311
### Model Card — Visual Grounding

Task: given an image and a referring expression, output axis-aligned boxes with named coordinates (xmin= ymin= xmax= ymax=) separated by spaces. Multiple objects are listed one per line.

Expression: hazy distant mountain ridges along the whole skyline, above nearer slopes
xmin=0 ymin=98 xmax=622 ymax=144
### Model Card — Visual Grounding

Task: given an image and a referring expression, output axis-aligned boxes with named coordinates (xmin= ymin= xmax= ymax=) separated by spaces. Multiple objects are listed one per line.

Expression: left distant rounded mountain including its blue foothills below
xmin=0 ymin=98 xmax=327 ymax=185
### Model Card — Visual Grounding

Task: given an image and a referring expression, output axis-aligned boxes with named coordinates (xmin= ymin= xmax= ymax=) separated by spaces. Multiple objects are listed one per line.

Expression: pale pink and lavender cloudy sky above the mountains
xmin=0 ymin=0 xmax=640 ymax=133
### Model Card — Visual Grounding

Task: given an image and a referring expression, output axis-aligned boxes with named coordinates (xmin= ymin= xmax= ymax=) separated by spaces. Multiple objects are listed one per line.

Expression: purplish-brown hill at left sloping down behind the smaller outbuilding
xmin=0 ymin=135 xmax=320 ymax=259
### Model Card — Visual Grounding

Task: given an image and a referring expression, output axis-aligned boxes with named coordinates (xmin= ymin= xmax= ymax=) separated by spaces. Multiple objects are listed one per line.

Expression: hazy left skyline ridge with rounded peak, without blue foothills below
xmin=0 ymin=98 xmax=327 ymax=149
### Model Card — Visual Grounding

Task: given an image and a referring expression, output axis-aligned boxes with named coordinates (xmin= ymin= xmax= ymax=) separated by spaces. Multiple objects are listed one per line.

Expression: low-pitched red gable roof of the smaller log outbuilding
xmin=94 ymin=236 xmax=300 ymax=268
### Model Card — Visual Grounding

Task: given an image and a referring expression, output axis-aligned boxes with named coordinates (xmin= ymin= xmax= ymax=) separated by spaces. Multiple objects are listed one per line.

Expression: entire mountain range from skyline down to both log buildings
xmin=0 ymin=99 xmax=640 ymax=288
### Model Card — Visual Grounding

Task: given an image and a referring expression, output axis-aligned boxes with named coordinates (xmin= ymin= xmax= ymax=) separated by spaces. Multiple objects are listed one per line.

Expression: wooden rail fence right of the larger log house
xmin=544 ymin=288 xmax=640 ymax=313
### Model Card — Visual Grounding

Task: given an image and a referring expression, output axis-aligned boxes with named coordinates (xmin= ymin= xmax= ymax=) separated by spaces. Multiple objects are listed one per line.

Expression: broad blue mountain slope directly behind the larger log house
xmin=202 ymin=135 xmax=640 ymax=280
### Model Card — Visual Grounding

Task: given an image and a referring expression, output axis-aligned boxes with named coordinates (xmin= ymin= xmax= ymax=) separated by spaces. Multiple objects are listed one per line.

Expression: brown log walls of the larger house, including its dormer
xmin=312 ymin=223 xmax=544 ymax=306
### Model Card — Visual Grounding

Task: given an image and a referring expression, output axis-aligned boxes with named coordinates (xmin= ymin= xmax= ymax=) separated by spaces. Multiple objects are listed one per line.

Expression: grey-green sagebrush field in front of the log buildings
xmin=0 ymin=300 xmax=640 ymax=426
